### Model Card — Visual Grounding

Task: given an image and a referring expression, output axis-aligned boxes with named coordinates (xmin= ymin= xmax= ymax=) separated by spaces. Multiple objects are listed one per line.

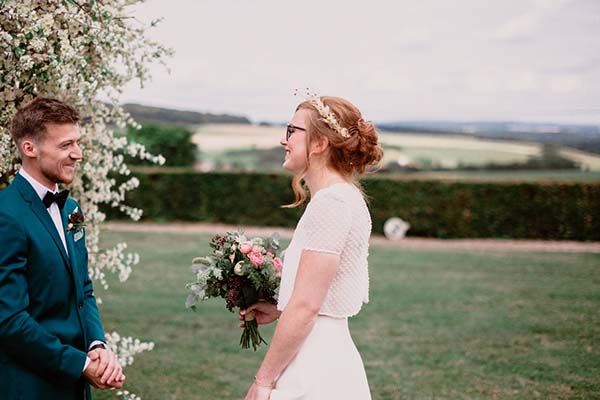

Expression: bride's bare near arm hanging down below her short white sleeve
xmin=256 ymin=250 xmax=340 ymax=384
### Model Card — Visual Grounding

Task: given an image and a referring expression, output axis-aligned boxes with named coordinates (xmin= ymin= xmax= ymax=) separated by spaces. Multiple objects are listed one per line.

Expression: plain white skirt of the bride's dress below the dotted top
xmin=271 ymin=315 xmax=371 ymax=400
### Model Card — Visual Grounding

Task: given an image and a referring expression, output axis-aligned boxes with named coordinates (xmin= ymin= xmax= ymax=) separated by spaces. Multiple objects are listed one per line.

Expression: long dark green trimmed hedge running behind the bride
xmin=108 ymin=172 xmax=600 ymax=240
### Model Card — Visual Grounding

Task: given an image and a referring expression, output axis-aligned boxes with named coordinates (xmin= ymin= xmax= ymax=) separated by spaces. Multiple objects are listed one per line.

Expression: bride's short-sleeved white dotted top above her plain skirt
xmin=278 ymin=183 xmax=371 ymax=318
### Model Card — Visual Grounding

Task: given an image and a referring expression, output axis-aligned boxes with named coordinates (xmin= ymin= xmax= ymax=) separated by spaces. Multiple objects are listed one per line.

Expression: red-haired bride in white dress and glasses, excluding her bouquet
xmin=240 ymin=96 xmax=383 ymax=400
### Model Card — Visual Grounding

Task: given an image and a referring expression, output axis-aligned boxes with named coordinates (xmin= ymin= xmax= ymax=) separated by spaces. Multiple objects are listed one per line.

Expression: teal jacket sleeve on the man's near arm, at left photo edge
xmin=0 ymin=211 xmax=86 ymax=381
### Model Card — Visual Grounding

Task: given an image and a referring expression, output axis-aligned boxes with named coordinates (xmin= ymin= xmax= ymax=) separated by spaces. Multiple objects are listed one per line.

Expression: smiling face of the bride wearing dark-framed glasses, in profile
xmin=279 ymin=110 xmax=308 ymax=174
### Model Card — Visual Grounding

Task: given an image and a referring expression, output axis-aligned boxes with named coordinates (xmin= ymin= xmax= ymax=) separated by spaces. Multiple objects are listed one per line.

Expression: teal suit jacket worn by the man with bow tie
xmin=0 ymin=174 xmax=105 ymax=400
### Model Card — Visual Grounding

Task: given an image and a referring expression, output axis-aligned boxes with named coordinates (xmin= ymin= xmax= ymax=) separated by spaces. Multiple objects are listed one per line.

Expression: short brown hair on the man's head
xmin=11 ymin=97 xmax=81 ymax=143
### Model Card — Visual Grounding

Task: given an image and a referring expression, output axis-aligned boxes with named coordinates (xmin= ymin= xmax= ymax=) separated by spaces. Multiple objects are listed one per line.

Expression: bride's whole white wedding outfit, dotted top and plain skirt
xmin=271 ymin=183 xmax=371 ymax=400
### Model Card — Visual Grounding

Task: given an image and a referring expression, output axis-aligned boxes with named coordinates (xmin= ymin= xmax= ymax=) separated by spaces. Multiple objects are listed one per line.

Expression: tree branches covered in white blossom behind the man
xmin=0 ymin=0 xmax=171 ymax=398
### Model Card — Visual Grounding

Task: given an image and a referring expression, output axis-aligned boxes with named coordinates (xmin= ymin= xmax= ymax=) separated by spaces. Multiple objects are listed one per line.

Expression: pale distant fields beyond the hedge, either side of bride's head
xmin=192 ymin=125 xmax=600 ymax=171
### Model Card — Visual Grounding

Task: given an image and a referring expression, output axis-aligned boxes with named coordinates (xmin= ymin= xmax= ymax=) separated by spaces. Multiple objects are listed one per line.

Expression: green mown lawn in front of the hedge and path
xmin=95 ymin=232 xmax=600 ymax=400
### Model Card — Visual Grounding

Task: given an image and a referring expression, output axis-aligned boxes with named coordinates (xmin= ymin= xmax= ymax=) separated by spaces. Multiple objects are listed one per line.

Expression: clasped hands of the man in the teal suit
xmin=83 ymin=348 xmax=125 ymax=389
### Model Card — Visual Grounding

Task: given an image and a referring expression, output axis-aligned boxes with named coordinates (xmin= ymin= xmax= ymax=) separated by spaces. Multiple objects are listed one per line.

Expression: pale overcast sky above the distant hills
xmin=123 ymin=0 xmax=600 ymax=124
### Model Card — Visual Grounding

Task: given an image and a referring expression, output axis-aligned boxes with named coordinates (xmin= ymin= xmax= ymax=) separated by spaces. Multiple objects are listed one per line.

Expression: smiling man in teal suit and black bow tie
xmin=0 ymin=98 xmax=125 ymax=400
